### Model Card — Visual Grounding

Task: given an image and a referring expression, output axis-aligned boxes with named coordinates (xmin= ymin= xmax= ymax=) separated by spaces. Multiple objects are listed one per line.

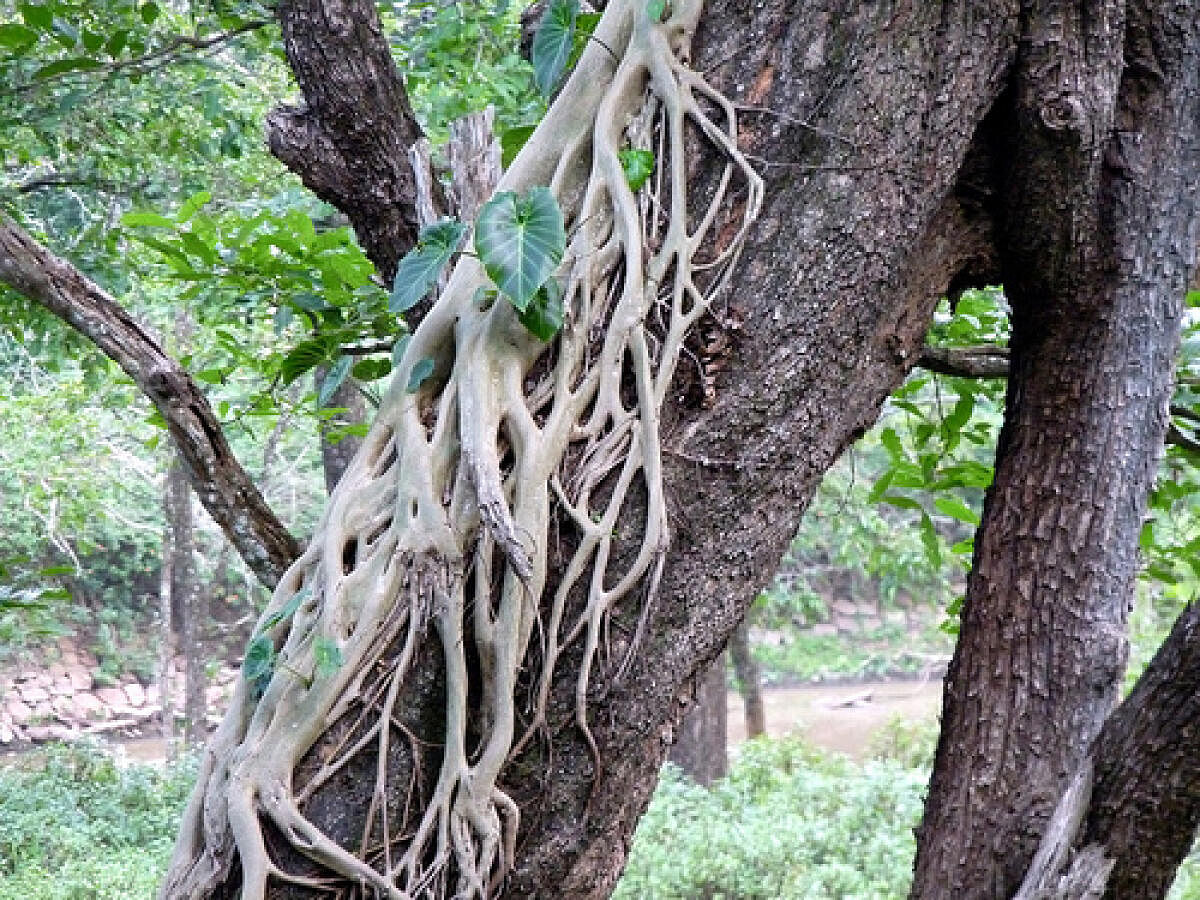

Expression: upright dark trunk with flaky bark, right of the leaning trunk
xmin=912 ymin=2 xmax=1200 ymax=900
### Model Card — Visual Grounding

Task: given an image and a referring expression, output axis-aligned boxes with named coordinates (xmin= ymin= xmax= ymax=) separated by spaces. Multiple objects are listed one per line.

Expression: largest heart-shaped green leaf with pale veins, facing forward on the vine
xmin=475 ymin=187 xmax=566 ymax=312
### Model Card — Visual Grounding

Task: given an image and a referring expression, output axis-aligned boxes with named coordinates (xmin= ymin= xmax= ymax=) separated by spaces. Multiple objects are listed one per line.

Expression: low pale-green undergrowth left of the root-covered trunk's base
xmin=0 ymin=748 xmax=194 ymax=900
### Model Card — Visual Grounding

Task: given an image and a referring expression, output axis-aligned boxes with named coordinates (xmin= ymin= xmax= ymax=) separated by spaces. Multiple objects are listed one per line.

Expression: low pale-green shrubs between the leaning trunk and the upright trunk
xmin=616 ymin=739 xmax=926 ymax=900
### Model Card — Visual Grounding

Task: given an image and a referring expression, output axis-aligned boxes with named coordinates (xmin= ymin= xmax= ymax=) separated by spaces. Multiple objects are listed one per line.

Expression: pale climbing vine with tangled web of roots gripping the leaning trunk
xmin=164 ymin=0 xmax=762 ymax=900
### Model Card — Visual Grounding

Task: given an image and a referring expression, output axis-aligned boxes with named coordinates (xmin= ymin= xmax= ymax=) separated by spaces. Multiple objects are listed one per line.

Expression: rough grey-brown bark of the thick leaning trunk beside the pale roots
xmin=166 ymin=1 xmax=1019 ymax=898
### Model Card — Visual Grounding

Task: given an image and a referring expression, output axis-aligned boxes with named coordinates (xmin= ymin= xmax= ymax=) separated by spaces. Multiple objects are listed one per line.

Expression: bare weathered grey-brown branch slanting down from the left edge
xmin=0 ymin=214 xmax=300 ymax=587
